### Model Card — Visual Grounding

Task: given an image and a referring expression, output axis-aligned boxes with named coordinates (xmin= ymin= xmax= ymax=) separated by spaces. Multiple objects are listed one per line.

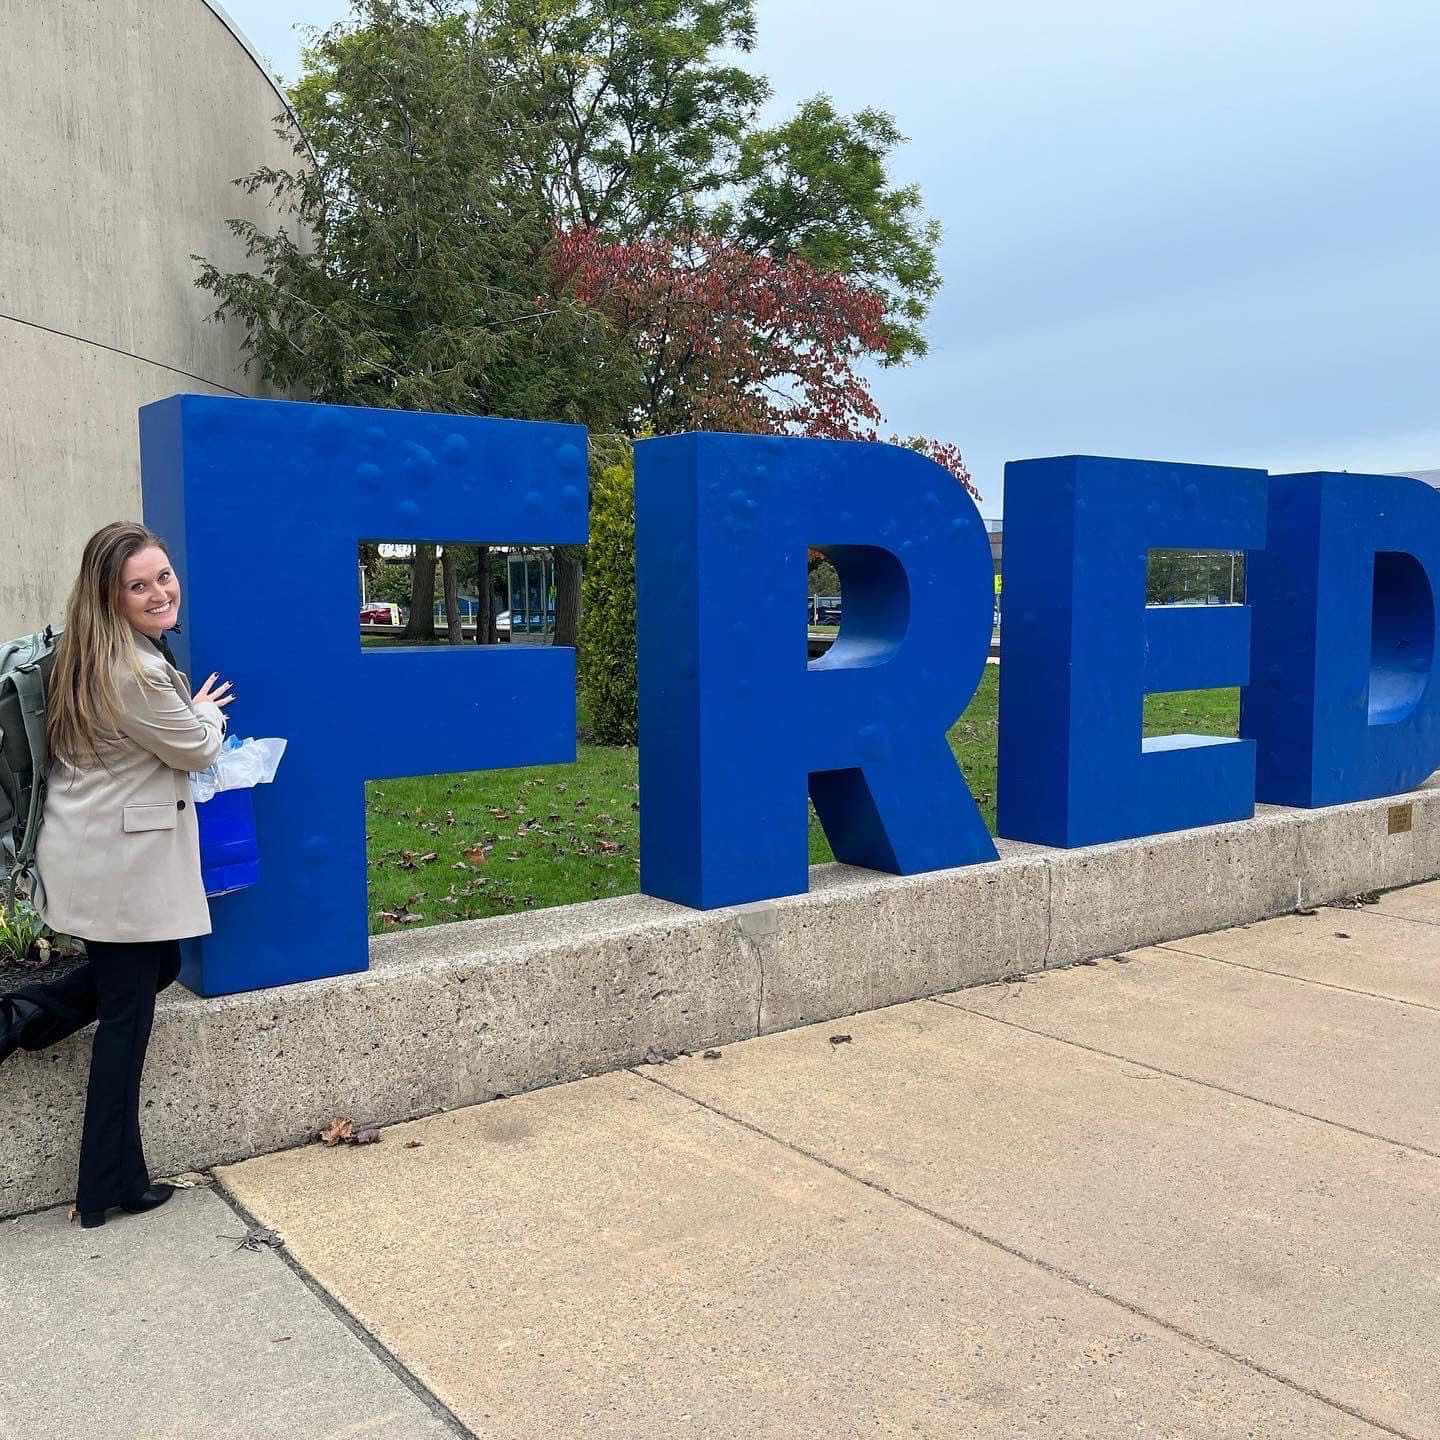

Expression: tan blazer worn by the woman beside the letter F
xmin=35 ymin=635 xmax=225 ymax=940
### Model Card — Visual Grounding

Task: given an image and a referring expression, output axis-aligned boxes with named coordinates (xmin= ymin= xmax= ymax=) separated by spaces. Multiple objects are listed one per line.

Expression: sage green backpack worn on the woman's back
xmin=0 ymin=625 xmax=60 ymax=916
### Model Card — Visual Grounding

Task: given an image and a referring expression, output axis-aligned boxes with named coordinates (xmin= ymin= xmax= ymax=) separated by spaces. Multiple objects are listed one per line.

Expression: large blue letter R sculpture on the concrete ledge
xmin=635 ymin=435 xmax=995 ymax=909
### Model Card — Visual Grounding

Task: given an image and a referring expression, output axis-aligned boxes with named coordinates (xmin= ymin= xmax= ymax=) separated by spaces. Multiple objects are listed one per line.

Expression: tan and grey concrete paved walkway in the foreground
xmin=0 ymin=884 xmax=1440 ymax=1440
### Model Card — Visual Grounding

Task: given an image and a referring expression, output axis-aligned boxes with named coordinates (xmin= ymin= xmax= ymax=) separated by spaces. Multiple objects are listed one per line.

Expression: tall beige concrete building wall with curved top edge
xmin=0 ymin=0 xmax=294 ymax=639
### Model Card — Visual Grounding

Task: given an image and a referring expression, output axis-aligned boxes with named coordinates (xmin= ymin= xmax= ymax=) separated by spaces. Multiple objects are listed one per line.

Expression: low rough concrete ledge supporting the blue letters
xmin=0 ymin=778 xmax=1440 ymax=1215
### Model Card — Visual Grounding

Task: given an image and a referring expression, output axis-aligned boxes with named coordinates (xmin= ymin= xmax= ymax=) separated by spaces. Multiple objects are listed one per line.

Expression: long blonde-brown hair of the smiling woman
xmin=46 ymin=520 xmax=170 ymax=769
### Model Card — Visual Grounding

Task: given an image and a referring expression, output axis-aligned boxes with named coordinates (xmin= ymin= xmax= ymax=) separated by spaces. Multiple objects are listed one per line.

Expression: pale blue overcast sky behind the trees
xmin=223 ymin=0 xmax=1440 ymax=516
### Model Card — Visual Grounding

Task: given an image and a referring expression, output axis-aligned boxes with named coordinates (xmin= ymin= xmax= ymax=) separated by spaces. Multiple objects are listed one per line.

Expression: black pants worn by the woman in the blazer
xmin=13 ymin=940 xmax=180 ymax=1211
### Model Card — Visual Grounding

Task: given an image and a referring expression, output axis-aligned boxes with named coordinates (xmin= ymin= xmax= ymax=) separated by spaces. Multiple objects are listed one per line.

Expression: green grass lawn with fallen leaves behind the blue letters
xmin=366 ymin=665 xmax=1240 ymax=932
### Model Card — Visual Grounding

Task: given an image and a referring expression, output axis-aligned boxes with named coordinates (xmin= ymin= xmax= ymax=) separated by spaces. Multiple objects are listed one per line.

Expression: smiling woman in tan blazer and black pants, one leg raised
xmin=0 ymin=521 xmax=235 ymax=1228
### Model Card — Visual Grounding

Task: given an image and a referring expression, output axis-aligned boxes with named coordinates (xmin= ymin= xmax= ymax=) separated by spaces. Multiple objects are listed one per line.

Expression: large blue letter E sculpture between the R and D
xmin=996 ymin=456 xmax=1266 ymax=847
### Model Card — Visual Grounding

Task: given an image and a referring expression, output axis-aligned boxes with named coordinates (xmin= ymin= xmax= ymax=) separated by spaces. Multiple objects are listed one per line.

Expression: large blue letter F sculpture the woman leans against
xmin=140 ymin=395 xmax=586 ymax=995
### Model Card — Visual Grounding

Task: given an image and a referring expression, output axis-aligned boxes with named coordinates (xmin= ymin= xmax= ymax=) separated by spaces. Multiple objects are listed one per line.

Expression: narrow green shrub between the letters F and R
xmin=576 ymin=446 xmax=639 ymax=744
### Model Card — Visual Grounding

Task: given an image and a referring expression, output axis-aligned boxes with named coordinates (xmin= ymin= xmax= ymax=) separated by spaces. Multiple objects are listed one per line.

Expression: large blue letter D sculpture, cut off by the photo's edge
xmin=1240 ymin=474 xmax=1440 ymax=806
